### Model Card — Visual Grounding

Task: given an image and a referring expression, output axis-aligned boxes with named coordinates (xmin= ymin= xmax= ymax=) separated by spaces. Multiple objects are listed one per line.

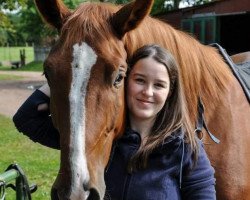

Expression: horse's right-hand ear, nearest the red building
xmin=112 ymin=0 xmax=154 ymax=38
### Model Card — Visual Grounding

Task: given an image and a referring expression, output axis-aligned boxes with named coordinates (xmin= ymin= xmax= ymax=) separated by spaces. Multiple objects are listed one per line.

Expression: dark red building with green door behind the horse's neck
xmin=157 ymin=0 xmax=250 ymax=54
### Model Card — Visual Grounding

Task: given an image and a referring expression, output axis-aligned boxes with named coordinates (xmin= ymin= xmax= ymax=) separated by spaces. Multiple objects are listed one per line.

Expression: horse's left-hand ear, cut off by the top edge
xmin=35 ymin=0 xmax=71 ymax=31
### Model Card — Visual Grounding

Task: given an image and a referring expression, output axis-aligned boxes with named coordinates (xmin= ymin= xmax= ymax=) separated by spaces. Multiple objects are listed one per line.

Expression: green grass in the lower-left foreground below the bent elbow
xmin=0 ymin=115 xmax=59 ymax=200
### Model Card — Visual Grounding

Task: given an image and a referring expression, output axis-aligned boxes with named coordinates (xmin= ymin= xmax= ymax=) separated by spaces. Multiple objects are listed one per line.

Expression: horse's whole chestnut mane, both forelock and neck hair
xmin=61 ymin=3 xmax=232 ymax=125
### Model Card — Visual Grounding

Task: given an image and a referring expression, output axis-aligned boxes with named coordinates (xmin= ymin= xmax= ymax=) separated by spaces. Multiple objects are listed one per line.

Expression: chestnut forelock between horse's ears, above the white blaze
xmin=61 ymin=3 xmax=115 ymax=48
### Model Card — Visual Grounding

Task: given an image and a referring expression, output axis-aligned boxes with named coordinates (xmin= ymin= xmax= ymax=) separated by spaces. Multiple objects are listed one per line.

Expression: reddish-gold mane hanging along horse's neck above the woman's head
xmin=125 ymin=17 xmax=232 ymax=122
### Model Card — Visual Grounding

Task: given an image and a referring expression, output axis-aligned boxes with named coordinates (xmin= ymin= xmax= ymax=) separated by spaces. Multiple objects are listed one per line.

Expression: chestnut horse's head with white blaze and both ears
xmin=36 ymin=0 xmax=153 ymax=200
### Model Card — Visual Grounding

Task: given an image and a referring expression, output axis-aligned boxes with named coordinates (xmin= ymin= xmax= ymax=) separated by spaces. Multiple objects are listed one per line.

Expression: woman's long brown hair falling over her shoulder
xmin=128 ymin=44 xmax=197 ymax=172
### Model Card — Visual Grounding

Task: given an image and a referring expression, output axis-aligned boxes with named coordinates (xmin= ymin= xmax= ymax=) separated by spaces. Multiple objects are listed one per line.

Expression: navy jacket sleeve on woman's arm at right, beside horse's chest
xmin=181 ymin=140 xmax=216 ymax=200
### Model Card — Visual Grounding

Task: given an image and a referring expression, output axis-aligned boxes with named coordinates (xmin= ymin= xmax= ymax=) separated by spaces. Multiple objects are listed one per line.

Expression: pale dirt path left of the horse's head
xmin=0 ymin=71 xmax=45 ymax=117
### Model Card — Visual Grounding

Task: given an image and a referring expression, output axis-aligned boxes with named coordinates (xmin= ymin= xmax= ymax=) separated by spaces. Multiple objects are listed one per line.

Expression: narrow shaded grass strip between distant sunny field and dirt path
xmin=0 ymin=61 xmax=43 ymax=72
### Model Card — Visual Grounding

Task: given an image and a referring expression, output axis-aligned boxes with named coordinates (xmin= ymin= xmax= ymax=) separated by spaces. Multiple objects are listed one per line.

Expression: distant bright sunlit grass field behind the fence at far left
xmin=0 ymin=47 xmax=34 ymax=63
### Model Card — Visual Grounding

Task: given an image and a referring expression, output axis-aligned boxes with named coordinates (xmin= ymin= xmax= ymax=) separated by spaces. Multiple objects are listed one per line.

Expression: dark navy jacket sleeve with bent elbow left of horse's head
xmin=13 ymin=90 xmax=60 ymax=149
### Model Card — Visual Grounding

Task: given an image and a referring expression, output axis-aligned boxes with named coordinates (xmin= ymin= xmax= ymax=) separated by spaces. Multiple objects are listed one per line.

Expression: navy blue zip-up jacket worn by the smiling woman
xmin=13 ymin=90 xmax=216 ymax=200
